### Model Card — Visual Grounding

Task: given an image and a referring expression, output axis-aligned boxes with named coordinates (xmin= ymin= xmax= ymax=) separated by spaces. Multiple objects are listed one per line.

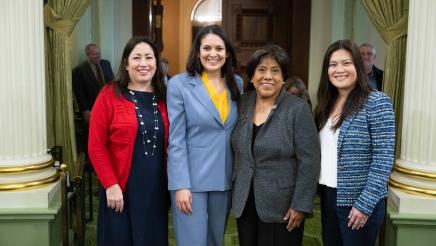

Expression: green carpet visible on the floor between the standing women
xmin=85 ymin=176 xmax=322 ymax=246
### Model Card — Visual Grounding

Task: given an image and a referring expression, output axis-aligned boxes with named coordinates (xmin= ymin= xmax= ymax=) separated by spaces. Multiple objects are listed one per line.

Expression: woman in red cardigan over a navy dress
xmin=88 ymin=37 xmax=168 ymax=246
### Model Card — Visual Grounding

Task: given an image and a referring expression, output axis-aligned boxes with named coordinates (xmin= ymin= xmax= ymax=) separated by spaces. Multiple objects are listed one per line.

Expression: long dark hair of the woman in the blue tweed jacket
xmin=315 ymin=39 xmax=371 ymax=131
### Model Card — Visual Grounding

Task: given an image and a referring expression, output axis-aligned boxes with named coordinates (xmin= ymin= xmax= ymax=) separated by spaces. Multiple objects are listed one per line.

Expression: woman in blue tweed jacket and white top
xmin=315 ymin=40 xmax=395 ymax=246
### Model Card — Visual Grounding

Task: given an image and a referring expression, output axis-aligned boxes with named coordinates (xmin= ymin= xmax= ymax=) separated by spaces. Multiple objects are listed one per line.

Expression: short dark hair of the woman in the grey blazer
xmin=245 ymin=44 xmax=290 ymax=80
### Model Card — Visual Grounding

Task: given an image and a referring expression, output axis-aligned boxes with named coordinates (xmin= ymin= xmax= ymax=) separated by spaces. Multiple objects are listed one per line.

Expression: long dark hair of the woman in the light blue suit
xmin=186 ymin=25 xmax=239 ymax=101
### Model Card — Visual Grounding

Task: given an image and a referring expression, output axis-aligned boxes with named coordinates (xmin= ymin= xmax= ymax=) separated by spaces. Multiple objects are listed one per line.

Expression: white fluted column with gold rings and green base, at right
xmin=385 ymin=0 xmax=436 ymax=245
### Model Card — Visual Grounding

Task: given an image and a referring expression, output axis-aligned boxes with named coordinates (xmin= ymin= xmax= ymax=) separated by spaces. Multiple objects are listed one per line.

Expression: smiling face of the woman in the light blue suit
xmin=199 ymin=33 xmax=228 ymax=73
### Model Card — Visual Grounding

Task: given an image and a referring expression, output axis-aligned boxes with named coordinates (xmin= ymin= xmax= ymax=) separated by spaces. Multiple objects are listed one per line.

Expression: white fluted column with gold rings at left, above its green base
xmin=0 ymin=0 xmax=59 ymax=208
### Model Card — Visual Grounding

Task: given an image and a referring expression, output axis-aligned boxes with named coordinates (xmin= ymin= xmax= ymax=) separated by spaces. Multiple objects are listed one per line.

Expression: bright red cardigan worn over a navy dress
xmin=88 ymin=84 xmax=169 ymax=192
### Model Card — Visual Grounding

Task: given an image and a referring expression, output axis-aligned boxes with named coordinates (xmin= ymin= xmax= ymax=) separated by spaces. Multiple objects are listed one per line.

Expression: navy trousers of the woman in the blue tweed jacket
xmin=320 ymin=185 xmax=386 ymax=246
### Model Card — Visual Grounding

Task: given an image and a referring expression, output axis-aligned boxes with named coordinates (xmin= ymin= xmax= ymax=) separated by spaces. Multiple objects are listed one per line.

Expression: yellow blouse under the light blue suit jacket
xmin=200 ymin=73 xmax=229 ymax=124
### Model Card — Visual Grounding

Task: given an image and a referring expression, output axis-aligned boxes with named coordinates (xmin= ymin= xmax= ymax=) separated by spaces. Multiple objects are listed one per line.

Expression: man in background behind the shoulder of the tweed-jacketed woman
xmin=359 ymin=43 xmax=383 ymax=91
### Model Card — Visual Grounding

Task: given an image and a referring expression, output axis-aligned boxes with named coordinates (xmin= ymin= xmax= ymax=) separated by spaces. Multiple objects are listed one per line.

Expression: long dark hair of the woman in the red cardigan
xmin=113 ymin=36 xmax=166 ymax=101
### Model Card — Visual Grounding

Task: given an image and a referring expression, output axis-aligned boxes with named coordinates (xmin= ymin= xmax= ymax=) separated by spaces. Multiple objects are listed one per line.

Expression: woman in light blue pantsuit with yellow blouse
xmin=167 ymin=25 xmax=242 ymax=246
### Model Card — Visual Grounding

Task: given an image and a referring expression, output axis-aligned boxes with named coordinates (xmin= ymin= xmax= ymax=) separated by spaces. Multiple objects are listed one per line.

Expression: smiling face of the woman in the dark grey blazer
xmin=252 ymin=57 xmax=283 ymax=99
